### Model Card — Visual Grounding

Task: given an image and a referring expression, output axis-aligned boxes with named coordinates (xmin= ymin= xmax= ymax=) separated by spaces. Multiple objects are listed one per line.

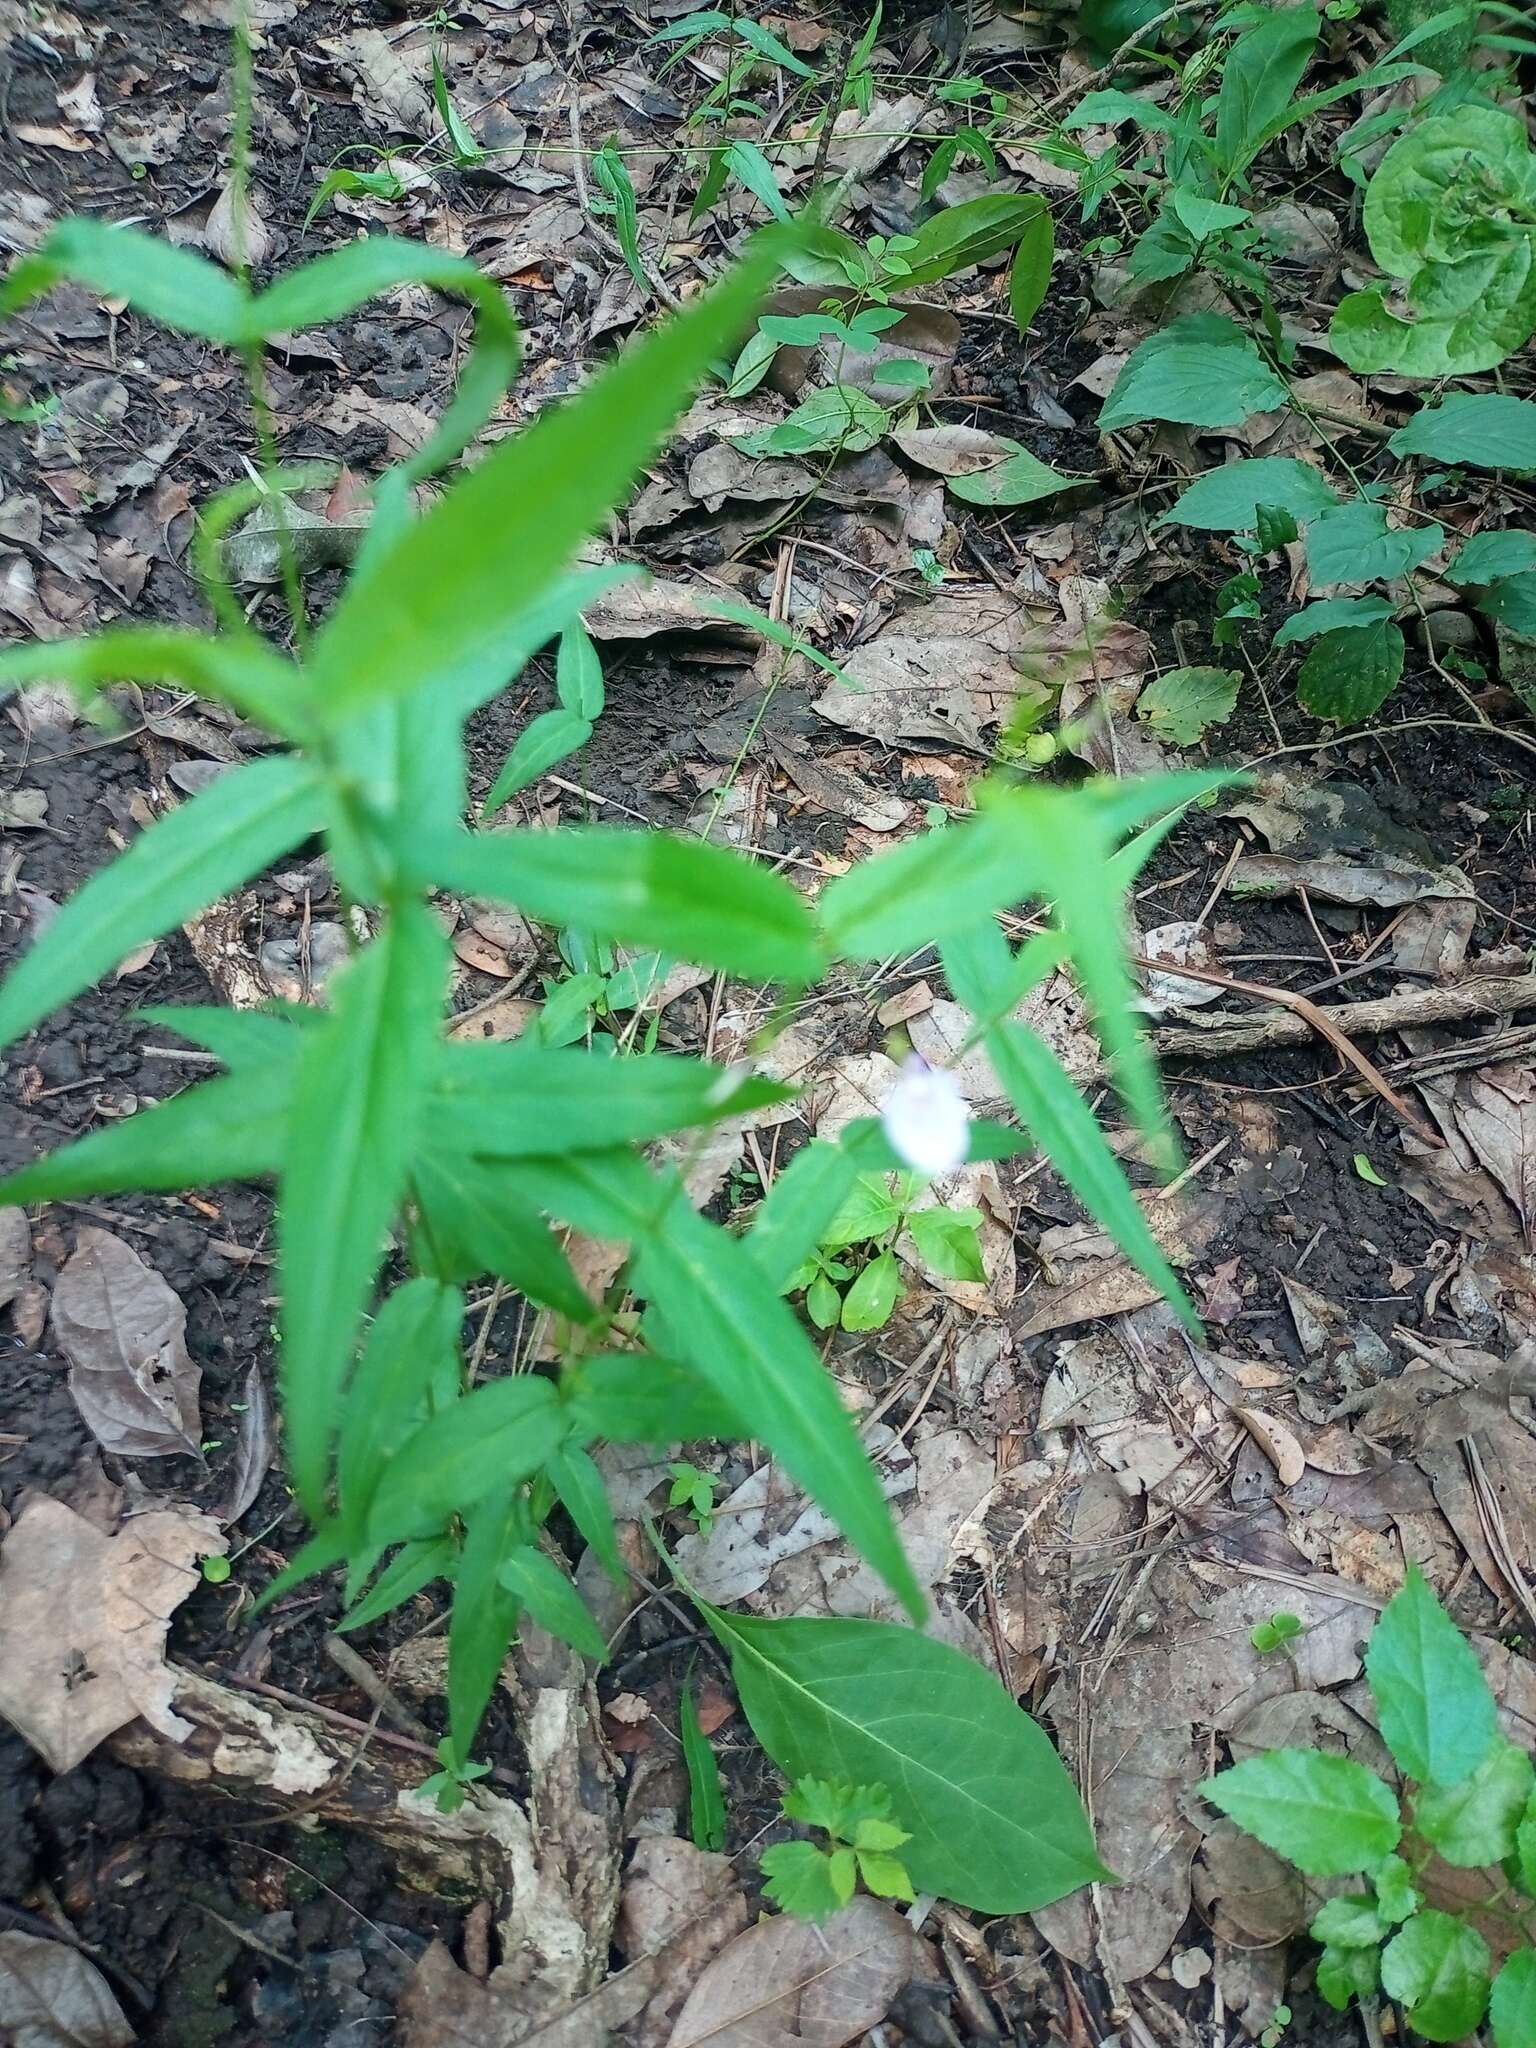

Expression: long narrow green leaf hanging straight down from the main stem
xmin=280 ymin=901 xmax=449 ymax=1520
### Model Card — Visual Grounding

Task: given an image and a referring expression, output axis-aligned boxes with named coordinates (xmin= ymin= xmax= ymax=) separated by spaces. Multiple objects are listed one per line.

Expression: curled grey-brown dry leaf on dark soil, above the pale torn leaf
xmin=53 ymin=1229 xmax=203 ymax=1458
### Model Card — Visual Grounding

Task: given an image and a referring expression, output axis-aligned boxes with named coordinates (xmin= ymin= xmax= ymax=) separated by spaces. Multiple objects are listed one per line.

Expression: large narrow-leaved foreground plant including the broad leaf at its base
xmin=0 ymin=221 xmax=1217 ymax=1911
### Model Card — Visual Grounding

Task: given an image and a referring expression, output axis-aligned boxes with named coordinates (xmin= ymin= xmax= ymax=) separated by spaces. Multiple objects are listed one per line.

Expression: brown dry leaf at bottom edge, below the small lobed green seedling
xmin=668 ymin=1898 xmax=918 ymax=2048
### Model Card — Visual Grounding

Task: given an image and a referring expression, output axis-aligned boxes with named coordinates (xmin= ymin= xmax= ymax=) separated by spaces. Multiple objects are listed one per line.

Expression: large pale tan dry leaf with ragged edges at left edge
xmin=0 ymin=1495 xmax=225 ymax=1772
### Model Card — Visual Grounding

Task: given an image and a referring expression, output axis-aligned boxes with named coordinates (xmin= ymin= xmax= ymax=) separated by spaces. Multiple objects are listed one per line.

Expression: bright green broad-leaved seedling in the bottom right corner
xmin=1200 ymin=1567 xmax=1536 ymax=2048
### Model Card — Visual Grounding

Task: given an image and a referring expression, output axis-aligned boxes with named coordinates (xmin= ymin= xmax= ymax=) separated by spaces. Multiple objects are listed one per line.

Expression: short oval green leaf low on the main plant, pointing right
xmin=369 ymin=1374 xmax=565 ymax=1544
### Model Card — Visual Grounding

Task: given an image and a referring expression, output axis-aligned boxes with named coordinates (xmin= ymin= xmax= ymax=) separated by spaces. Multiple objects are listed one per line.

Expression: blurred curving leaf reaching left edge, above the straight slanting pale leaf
xmin=0 ymin=627 xmax=311 ymax=741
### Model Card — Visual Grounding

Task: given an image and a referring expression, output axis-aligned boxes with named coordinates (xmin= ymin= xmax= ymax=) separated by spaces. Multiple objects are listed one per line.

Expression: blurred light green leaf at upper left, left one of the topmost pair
xmin=0 ymin=219 xmax=250 ymax=346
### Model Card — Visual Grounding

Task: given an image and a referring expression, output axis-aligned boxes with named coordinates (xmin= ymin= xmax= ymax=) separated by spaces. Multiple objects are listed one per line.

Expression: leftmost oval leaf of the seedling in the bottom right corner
xmin=1200 ymin=1749 xmax=1403 ymax=1878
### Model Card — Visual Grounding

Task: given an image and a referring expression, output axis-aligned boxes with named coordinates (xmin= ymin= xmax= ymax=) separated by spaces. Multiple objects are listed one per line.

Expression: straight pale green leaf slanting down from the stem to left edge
xmin=0 ymin=760 xmax=326 ymax=1044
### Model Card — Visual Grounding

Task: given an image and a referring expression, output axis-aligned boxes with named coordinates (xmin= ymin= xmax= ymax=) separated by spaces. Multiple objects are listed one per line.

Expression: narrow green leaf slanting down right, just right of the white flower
xmin=985 ymin=1024 xmax=1200 ymax=1335
